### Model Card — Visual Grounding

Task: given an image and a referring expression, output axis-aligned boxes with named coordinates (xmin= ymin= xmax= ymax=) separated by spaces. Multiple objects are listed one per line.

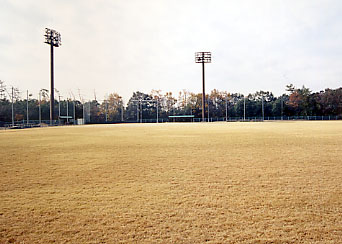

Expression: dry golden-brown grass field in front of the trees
xmin=0 ymin=121 xmax=342 ymax=243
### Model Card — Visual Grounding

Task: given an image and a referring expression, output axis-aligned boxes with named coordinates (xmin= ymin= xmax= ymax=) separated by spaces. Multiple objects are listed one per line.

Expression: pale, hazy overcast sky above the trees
xmin=0 ymin=0 xmax=342 ymax=102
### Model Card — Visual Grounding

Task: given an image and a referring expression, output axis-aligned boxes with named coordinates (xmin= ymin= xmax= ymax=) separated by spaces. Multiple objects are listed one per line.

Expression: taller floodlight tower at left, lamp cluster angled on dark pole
xmin=44 ymin=28 xmax=62 ymax=125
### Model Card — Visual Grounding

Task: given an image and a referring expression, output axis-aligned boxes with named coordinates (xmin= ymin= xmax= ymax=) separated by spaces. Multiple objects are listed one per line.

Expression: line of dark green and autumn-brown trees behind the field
xmin=0 ymin=81 xmax=342 ymax=123
